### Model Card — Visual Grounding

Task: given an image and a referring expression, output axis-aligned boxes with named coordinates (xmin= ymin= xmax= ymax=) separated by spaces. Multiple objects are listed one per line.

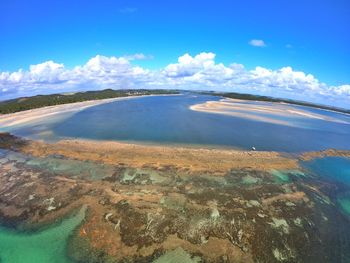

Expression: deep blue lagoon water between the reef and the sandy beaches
xmin=4 ymin=94 xmax=350 ymax=152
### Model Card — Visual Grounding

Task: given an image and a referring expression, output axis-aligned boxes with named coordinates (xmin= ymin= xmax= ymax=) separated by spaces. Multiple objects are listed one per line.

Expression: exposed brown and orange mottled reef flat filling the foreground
xmin=0 ymin=134 xmax=350 ymax=262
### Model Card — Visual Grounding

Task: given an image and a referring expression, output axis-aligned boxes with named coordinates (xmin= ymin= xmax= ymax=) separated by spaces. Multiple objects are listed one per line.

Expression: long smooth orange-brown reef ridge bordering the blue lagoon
xmin=0 ymin=134 xmax=299 ymax=176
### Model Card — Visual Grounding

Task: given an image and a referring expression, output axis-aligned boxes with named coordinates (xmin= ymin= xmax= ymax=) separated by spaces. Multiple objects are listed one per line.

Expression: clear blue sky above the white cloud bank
xmin=0 ymin=0 xmax=350 ymax=107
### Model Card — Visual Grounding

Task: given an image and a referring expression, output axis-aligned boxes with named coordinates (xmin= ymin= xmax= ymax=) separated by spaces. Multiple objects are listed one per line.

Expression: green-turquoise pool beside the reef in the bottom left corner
xmin=0 ymin=208 xmax=86 ymax=263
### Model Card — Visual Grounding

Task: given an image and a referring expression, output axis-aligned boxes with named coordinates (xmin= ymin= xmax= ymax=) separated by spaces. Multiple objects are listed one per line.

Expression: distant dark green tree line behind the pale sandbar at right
xmin=203 ymin=91 xmax=350 ymax=114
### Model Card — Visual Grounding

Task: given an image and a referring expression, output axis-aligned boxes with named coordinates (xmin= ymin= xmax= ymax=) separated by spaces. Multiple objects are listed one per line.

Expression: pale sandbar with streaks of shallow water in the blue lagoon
xmin=190 ymin=99 xmax=350 ymax=126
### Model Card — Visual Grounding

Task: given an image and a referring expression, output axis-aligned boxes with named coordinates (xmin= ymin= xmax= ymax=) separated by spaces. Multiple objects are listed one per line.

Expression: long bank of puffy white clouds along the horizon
xmin=0 ymin=52 xmax=350 ymax=108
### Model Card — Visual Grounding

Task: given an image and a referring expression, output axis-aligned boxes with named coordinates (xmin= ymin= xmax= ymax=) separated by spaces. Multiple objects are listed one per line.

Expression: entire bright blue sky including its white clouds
xmin=0 ymin=0 xmax=350 ymax=108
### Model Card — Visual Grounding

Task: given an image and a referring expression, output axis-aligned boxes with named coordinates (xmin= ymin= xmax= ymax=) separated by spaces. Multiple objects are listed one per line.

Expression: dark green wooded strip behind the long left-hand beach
xmin=0 ymin=89 xmax=179 ymax=114
